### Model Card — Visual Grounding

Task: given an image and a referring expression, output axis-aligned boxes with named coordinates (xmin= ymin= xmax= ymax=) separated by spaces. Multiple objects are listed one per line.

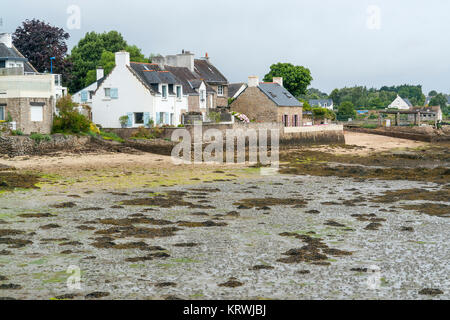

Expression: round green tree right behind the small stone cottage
xmin=263 ymin=63 xmax=313 ymax=97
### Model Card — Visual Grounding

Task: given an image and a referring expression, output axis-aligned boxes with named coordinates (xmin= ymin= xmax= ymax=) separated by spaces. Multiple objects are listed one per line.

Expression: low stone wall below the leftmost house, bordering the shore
xmin=0 ymin=134 xmax=91 ymax=157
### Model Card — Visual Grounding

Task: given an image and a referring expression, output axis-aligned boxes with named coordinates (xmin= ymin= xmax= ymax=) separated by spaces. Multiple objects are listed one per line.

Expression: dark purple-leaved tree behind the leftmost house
xmin=13 ymin=19 xmax=72 ymax=83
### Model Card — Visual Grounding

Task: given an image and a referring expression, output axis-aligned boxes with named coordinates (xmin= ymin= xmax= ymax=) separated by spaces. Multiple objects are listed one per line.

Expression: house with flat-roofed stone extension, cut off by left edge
xmin=0 ymin=33 xmax=61 ymax=134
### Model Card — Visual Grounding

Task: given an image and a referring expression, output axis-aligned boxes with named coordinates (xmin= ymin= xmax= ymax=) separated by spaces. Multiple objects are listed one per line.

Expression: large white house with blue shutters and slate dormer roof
xmin=92 ymin=51 xmax=188 ymax=128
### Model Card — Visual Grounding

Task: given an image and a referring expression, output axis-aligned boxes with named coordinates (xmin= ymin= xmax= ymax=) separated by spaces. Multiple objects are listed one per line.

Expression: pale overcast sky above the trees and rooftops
xmin=0 ymin=0 xmax=450 ymax=94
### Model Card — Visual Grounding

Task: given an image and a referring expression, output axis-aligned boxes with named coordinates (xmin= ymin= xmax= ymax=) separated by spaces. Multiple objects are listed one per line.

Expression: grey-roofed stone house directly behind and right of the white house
xmin=152 ymin=50 xmax=228 ymax=115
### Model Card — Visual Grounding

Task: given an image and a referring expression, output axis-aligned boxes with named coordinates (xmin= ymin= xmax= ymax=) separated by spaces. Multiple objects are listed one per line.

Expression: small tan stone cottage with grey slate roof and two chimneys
xmin=230 ymin=76 xmax=303 ymax=127
